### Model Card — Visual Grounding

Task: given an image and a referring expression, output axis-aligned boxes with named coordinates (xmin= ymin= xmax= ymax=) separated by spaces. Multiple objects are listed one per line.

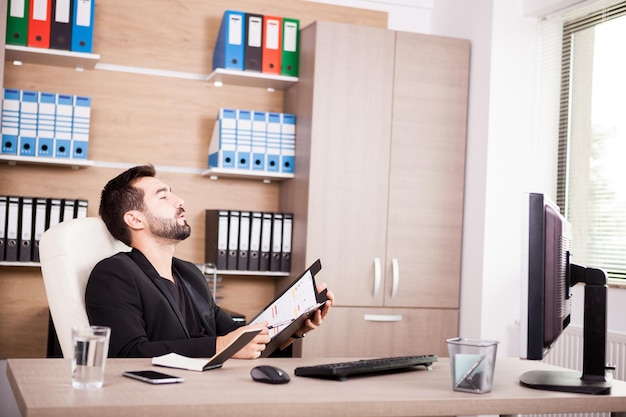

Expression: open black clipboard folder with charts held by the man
xmin=250 ymin=259 xmax=328 ymax=358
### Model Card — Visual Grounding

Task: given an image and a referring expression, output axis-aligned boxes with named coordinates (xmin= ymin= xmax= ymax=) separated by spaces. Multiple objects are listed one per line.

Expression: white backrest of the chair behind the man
xmin=39 ymin=217 xmax=130 ymax=358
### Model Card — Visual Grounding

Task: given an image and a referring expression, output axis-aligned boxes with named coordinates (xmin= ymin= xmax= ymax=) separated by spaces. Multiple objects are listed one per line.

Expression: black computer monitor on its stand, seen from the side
xmin=520 ymin=193 xmax=611 ymax=394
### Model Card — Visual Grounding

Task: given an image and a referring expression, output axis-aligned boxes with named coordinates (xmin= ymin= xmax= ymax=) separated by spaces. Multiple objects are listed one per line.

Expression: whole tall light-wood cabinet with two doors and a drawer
xmin=280 ymin=22 xmax=469 ymax=356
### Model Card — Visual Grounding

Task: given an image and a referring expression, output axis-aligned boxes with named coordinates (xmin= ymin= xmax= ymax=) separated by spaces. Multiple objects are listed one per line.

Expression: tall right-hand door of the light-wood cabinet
xmin=385 ymin=32 xmax=469 ymax=308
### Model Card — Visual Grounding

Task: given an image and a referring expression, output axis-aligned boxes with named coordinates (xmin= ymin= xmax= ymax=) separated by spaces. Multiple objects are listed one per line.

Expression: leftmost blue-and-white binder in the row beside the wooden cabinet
xmin=209 ymin=109 xmax=237 ymax=168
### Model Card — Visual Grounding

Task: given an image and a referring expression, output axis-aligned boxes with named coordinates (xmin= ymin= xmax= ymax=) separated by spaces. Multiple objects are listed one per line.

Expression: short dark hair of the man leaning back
xmin=99 ymin=165 xmax=156 ymax=246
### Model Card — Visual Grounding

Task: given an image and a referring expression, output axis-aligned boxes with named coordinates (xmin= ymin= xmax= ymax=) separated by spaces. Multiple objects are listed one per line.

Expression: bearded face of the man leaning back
xmin=134 ymin=177 xmax=191 ymax=240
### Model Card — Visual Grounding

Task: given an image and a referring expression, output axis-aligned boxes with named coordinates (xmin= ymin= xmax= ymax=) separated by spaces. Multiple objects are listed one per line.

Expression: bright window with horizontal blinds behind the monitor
xmin=557 ymin=2 xmax=626 ymax=279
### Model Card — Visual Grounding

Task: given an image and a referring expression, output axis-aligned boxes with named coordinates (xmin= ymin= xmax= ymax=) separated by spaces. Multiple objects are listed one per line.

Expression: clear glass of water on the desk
xmin=72 ymin=326 xmax=111 ymax=389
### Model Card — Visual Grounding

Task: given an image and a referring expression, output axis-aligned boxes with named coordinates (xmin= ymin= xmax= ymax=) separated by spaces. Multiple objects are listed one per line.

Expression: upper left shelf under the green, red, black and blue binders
xmin=4 ymin=45 xmax=100 ymax=69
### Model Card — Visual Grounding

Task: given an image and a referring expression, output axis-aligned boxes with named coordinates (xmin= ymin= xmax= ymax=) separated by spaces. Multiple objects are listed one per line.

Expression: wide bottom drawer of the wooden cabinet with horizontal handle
xmin=302 ymin=307 xmax=458 ymax=358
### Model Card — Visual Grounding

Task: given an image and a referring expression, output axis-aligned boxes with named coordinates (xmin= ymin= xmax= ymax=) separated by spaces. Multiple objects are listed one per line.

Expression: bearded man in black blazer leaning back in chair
xmin=85 ymin=165 xmax=334 ymax=359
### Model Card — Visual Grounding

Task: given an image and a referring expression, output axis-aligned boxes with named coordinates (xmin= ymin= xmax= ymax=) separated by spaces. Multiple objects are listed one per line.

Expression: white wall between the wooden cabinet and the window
xmin=316 ymin=0 xmax=626 ymax=356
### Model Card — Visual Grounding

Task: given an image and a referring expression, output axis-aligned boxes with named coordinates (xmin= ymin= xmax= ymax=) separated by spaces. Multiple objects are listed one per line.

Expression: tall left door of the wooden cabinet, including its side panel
xmin=288 ymin=22 xmax=394 ymax=306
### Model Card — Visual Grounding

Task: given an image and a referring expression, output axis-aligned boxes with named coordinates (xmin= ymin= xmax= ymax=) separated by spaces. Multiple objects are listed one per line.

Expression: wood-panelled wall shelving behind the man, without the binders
xmin=0 ymin=0 xmax=387 ymax=358
